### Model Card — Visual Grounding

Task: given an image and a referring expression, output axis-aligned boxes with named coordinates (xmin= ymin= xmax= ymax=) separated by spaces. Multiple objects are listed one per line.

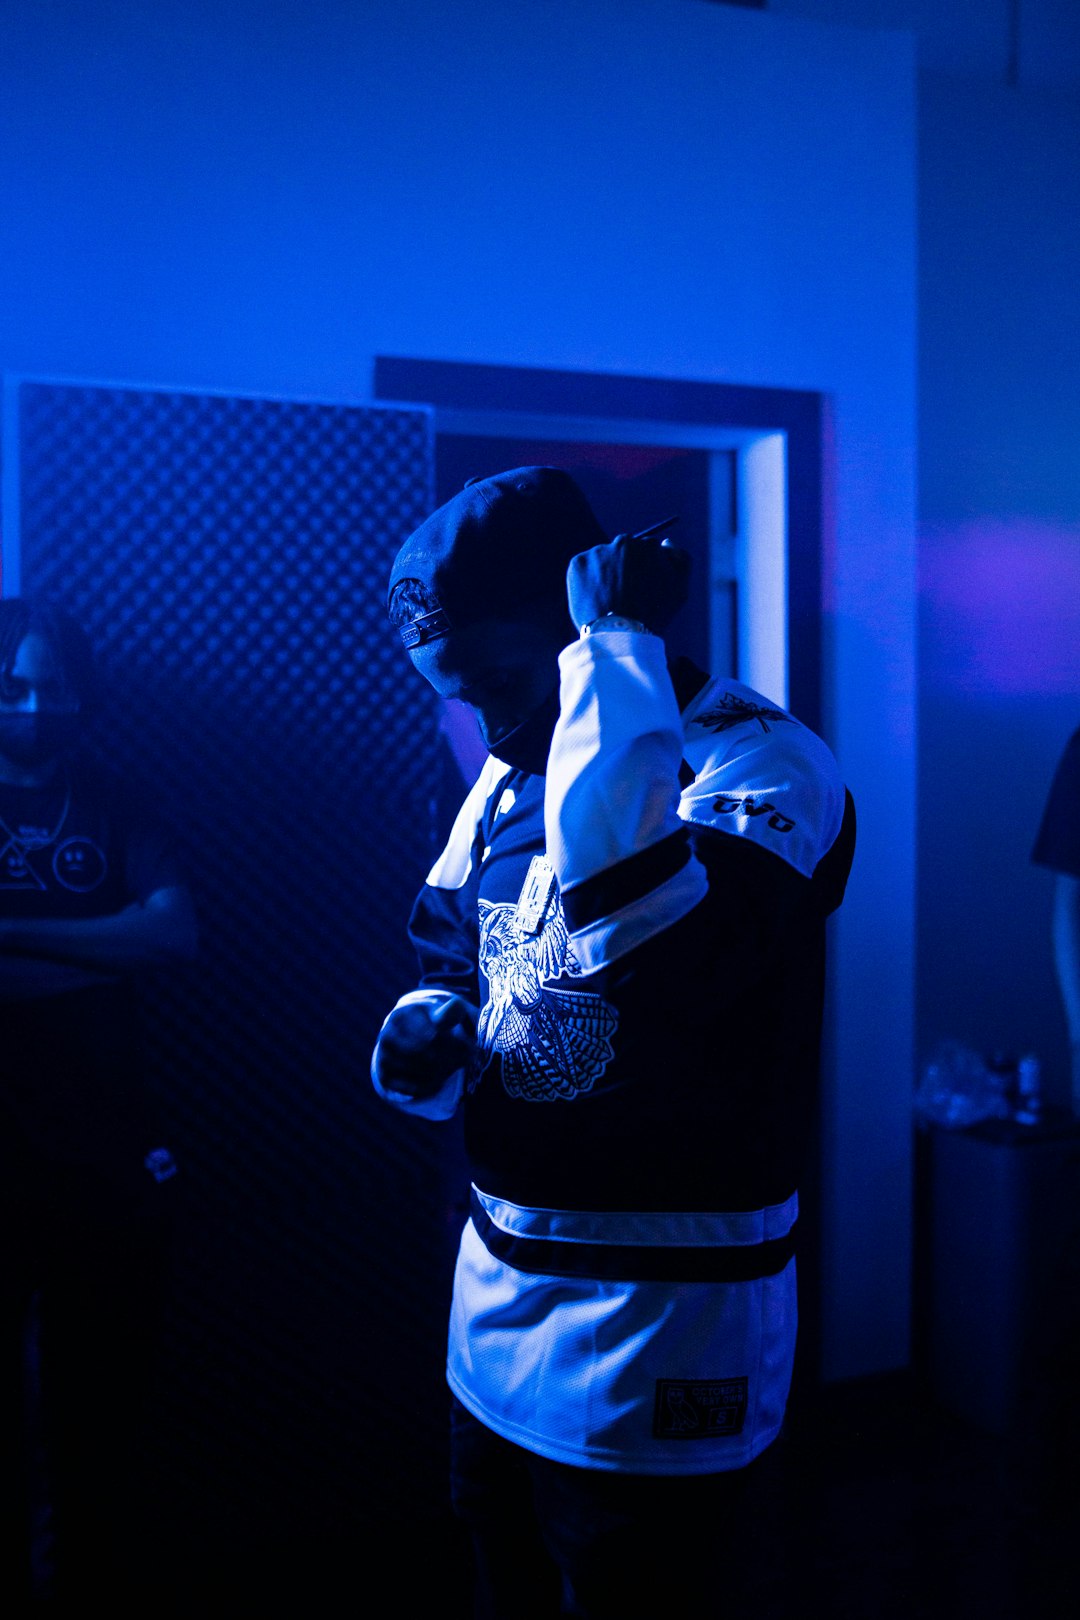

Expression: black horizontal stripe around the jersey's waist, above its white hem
xmin=471 ymin=1191 xmax=795 ymax=1283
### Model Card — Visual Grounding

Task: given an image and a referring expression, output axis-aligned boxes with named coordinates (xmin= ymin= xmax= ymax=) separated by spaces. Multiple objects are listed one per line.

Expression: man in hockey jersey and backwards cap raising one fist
xmin=372 ymin=468 xmax=853 ymax=1620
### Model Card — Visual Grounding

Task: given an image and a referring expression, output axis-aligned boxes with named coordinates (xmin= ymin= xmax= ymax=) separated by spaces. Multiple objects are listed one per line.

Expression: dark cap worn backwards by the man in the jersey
xmin=389 ymin=467 xmax=607 ymax=646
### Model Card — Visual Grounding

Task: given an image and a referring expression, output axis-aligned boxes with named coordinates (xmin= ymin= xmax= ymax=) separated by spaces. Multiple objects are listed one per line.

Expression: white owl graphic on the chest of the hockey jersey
xmin=470 ymin=897 xmax=619 ymax=1103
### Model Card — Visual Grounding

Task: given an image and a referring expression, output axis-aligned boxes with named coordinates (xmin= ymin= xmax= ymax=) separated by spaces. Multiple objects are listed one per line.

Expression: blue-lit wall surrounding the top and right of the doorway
xmin=0 ymin=0 xmax=915 ymax=1377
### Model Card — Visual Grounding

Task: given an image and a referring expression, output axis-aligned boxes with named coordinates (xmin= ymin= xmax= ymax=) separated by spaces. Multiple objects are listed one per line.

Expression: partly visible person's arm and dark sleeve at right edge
xmin=1031 ymin=729 xmax=1080 ymax=1118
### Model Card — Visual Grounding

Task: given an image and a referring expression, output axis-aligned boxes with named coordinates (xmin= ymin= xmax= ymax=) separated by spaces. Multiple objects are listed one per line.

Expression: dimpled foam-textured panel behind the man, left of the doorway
xmin=8 ymin=382 xmax=452 ymax=1581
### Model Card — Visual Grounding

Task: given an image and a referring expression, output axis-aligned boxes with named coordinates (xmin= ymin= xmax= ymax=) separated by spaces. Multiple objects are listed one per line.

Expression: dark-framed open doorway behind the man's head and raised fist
xmin=374 ymin=356 xmax=809 ymax=729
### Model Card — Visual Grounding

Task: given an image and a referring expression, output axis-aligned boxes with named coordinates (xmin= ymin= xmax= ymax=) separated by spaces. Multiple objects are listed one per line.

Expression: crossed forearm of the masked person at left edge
xmin=0 ymin=889 xmax=198 ymax=974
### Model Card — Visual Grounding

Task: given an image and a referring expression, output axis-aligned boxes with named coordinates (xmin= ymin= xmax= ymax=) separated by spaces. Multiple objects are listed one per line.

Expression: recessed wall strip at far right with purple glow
xmin=918 ymin=78 xmax=1080 ymax=1102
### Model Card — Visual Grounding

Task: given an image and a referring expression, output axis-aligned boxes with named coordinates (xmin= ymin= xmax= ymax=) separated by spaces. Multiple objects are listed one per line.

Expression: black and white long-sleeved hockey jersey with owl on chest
xmin=372 ymin=630 xmax=853 ymax=1474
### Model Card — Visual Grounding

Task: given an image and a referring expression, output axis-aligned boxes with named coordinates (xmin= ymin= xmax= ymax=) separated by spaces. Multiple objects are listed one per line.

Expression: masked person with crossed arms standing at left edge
xmin=0 ymin=599 xmax=198 ymax=1612
